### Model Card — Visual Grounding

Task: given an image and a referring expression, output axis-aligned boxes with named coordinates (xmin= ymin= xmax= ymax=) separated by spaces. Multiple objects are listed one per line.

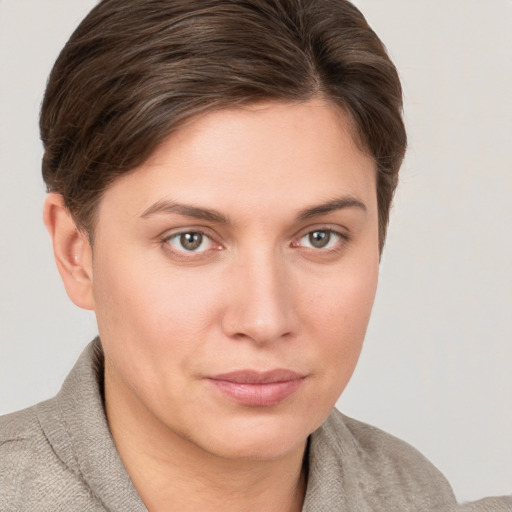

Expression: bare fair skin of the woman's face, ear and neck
xmin=44 ymin=99 xmax=379 ymax=512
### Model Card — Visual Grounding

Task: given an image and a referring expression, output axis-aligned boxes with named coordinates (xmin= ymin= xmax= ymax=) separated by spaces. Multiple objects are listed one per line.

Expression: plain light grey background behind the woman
xmin=0 ymin=0 xmax=512 ymax=500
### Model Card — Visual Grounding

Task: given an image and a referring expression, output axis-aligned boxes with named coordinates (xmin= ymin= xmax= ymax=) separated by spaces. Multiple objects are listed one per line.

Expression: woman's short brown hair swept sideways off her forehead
xmin=40 ymin=0 xmax=406 ymax=250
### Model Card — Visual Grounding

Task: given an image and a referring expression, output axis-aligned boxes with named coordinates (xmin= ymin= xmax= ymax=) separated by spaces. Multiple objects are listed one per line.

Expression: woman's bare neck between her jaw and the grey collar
xmin=105 ymin=368 xmax=306 ymax=512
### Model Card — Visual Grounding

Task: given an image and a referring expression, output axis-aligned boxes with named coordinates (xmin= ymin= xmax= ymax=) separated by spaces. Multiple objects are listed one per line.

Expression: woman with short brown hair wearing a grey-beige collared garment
xmin=2 ymin=0 xmax=512 ymax=511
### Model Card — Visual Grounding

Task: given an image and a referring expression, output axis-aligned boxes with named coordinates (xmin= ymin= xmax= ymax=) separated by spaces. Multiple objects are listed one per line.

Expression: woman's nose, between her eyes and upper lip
xmin=222 ymin=252 xmax=298 ymax=345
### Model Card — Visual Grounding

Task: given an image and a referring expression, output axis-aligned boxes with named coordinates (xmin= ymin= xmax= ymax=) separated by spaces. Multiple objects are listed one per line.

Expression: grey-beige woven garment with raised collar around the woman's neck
xmin=0 ymin=339 xmax=502 ymax=512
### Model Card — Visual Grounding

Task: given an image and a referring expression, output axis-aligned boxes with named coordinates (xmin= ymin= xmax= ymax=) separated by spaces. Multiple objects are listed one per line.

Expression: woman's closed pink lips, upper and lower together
xmin=208 ymin=369 xmax=305 ymax=407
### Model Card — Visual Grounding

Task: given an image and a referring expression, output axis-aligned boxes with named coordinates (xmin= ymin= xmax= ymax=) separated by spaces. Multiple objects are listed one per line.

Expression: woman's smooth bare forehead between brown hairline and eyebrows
xmin=100 ymin=99 xmax=375 ymax=223
